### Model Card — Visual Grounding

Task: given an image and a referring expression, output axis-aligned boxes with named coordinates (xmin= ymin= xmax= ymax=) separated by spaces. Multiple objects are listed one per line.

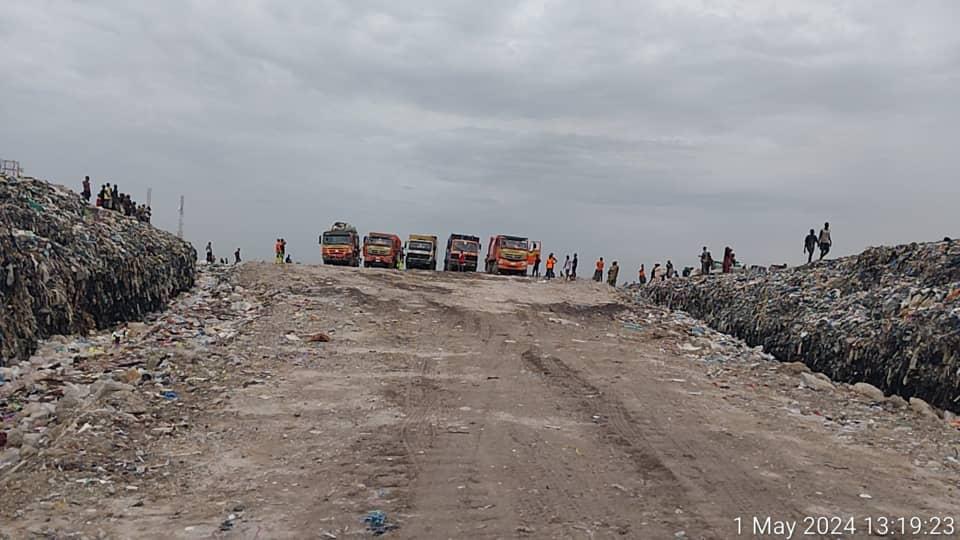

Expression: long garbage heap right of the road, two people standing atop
xmin=634 ymin=240 xmax=960 ymax=412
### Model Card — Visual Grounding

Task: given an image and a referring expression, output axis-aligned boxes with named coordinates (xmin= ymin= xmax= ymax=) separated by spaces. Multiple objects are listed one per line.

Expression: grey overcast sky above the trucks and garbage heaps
xmin=0 ymin=0 xmax=960 ymax=278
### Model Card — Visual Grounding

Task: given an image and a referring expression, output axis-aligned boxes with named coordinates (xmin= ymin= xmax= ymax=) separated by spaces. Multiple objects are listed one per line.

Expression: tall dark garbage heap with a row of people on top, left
xmin=0 ymin=176 xmax=197 ymax=366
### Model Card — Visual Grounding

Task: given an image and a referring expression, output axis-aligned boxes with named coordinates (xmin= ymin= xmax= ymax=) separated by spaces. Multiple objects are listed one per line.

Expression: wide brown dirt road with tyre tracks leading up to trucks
xmin=0 ymin=264 xmax=960 ymax=539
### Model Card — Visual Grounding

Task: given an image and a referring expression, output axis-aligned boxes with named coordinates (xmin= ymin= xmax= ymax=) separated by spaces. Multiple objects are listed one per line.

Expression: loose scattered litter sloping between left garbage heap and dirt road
xmin=0 ymin=265 xmax=263 ymax=494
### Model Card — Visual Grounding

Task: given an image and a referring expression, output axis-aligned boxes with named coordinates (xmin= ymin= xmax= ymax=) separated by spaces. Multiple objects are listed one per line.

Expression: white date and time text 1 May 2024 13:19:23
xmin=733 ymin=516 xmax=957 ymax=540
